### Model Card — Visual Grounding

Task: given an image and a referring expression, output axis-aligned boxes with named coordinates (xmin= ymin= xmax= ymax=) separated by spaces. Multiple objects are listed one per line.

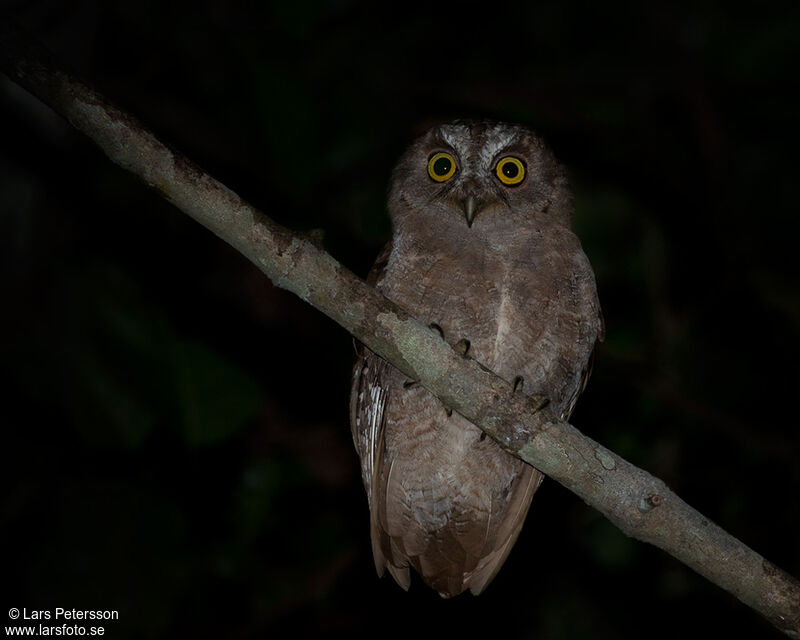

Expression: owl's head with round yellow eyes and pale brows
xmin=389 ymin=121 xmax=572 ymax=233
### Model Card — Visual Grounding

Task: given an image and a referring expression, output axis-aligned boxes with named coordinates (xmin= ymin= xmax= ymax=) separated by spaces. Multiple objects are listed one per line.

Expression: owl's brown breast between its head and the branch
xmin=379 ymin=229 xmax=594 ymax=410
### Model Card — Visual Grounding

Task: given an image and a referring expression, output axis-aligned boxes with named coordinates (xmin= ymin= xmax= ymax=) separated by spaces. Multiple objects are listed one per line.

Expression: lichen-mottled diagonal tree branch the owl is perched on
xmin=0 ymin=25 xmax=800 ymax=638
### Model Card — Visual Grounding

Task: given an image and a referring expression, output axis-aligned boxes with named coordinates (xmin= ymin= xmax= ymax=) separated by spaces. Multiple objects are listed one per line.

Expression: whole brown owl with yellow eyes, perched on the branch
xmin=350 ymin=121 xmax=603 ymax=597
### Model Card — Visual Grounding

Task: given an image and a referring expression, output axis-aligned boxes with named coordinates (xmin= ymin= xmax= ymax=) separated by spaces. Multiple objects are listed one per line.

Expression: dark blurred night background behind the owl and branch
xmin=0 ymin=0 xmax=800 ymax=640
